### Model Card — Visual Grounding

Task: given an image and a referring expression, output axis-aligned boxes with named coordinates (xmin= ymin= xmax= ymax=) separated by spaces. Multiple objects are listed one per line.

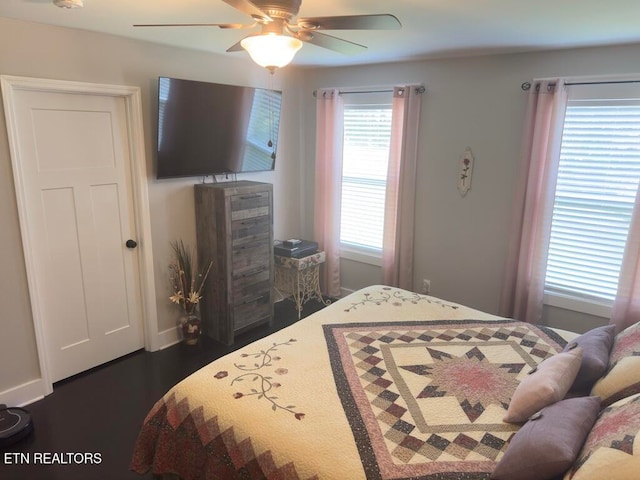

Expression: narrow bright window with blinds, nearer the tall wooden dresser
xmin=340 ymin=98 xmax=391 ymax=263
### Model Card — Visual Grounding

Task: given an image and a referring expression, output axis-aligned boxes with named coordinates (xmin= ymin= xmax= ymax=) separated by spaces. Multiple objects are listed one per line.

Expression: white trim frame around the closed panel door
xmin=0 ymin=75 xmax=160 ymax=396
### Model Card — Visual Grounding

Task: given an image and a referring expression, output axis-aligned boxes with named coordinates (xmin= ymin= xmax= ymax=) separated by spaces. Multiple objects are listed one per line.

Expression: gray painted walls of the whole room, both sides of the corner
xmin=0 ymin=18 xmax=640 ymax=399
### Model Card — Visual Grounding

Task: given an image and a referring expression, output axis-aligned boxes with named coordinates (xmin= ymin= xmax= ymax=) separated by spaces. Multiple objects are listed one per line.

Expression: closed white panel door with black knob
xmin=13 ymin=86 xmax=144 ymax=382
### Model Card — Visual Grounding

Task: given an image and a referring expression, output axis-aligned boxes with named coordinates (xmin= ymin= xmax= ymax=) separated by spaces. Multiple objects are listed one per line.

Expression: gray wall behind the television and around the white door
xmin=0 ymin=17 xmax=301 ymax=403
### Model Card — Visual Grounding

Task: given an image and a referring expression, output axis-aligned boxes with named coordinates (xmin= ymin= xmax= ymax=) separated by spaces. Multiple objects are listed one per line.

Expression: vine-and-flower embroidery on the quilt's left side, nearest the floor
xmin=214 ymin=338 xmax=305 ymax=420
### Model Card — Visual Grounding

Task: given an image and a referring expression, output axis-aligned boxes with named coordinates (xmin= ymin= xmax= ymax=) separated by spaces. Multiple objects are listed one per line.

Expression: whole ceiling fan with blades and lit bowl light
xmin=134 ymin=0 xmax=402 ymax=72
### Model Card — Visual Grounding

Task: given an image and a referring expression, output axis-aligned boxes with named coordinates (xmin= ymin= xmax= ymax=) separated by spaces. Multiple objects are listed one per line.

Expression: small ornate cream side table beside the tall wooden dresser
xmin=275 ymin=252 xmax=331 ymax=320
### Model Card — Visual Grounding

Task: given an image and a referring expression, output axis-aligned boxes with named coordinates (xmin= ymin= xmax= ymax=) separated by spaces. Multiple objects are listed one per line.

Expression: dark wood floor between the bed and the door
xmin=0 ymin=300 xmax=330 ymax=480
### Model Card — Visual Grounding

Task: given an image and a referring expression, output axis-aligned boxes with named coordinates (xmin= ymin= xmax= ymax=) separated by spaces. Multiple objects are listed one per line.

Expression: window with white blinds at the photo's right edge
xmin=545 ymin=85 xmax=640 ymax=316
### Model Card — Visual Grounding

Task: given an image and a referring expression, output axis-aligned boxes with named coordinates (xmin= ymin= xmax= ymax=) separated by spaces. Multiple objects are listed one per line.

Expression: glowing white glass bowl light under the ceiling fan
xmin=240 ymin=33 xmax=302 ymax=72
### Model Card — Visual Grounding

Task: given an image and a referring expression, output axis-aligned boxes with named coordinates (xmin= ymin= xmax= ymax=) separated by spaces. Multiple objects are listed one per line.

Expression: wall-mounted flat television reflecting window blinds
xmin=157 ymin=77 xmax=282 ymax=178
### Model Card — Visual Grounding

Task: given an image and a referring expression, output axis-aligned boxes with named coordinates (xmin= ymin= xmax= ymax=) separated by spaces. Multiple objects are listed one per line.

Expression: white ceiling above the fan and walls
xmin=0 ymin=0 xmax=640 ymax=66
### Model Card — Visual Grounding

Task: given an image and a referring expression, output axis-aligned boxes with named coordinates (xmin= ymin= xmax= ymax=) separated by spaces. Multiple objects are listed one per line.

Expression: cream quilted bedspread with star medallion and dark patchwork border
xmin=131 ymin=286 xmax=576 ymax=480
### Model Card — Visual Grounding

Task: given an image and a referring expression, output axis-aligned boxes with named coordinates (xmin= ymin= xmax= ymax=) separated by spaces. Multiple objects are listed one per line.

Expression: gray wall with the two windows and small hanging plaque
xmin=301 ymin=45 xmax=640 ymax=331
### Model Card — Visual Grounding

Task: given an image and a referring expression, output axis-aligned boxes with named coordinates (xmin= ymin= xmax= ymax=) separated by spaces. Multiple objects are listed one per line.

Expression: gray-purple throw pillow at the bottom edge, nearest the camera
xmin=491 ymin=397 xmax=600 ymax=480
